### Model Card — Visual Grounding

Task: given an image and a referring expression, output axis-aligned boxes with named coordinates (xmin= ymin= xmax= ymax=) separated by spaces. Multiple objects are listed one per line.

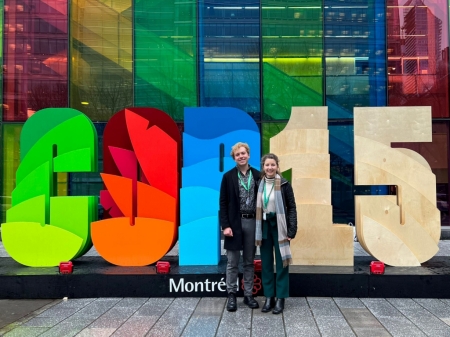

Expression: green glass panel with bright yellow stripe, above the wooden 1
xmin=261 ymin=0 xmax=323 ymax=120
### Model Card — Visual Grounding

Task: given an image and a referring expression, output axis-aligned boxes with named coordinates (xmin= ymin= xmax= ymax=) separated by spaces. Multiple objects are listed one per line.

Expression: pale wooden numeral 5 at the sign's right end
xmin=354 ymin=107 xmax=441 ymax=266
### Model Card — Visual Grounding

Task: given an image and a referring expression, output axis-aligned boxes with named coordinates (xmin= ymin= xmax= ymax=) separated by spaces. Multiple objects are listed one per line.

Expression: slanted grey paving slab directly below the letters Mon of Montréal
xmin=147 ymin=298 xmax=199 ymax=337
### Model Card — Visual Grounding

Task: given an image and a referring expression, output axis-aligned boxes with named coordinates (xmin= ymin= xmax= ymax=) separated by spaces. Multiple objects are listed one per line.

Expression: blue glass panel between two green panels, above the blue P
xmin=199 ymin=0 xmax=261 ymax=120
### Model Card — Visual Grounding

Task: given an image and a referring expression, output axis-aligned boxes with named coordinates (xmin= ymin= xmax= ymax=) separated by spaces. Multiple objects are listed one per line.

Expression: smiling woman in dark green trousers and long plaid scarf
xmin=256 ymin=153 xmax=297 ymax=314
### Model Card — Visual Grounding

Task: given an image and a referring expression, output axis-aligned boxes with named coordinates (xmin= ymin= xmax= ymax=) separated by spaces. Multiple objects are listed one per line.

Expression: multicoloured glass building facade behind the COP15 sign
xmin=0 ymin=0 xmax=450 ymax=225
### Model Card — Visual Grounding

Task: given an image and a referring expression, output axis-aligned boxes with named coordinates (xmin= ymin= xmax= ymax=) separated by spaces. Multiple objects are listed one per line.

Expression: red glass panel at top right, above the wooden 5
xmin=387 ymin=0 xmax=449 ymax=117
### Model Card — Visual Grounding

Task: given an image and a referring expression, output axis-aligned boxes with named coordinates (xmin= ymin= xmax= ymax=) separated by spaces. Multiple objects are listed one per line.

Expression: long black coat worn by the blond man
xmin=219 ymin=167 xmax=260 ymax=250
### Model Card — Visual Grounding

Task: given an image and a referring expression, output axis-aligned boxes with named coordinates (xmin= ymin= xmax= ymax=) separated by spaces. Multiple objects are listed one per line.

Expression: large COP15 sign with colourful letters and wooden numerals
xmin=2 ymin=107 xmax=440 ymax=267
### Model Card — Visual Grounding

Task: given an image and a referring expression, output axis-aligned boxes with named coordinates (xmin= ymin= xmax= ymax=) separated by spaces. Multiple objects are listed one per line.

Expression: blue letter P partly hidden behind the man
xmin=179 ymin=108 xmax=261 ymax=266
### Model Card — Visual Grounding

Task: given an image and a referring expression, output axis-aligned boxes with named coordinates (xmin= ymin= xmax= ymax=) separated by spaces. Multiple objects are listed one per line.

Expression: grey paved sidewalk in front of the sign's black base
xmin=0 ymin=297 xmax=450 ymax=337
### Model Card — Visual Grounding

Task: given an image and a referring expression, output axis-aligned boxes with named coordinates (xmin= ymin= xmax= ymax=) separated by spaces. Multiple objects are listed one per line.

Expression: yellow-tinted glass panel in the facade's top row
xmin=70 ymin=0 xmax=133 ymax=121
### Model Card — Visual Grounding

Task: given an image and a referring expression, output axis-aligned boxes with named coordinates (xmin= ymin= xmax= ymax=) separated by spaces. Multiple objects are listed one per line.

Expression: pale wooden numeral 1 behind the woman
xmin=270 ymin=107 xmax=353 ymax=266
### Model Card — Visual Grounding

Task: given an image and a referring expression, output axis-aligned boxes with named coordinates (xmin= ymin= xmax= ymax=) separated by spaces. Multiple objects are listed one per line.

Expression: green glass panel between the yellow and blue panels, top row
xmin=134 ymin=0 xmax=197 ymax=121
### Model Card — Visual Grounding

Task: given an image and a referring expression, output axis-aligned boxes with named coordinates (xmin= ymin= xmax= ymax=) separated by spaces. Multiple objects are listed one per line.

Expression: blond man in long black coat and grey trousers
xmin=219 ymin=143 xmax=260 ymax=311
